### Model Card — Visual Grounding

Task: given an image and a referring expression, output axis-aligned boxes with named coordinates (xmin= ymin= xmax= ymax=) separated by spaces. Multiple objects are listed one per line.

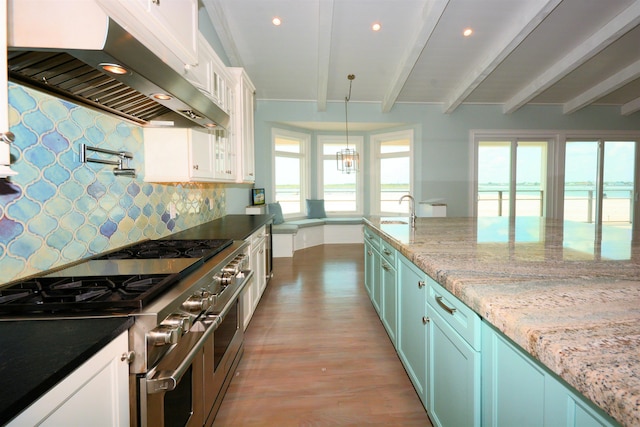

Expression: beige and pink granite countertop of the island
xmin=365 ymin=217 xmax=640 ymax=426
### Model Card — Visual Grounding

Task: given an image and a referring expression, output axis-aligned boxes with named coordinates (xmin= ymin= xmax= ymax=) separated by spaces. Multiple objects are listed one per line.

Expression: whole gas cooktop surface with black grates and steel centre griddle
xmin=0 ymin=239 xmax=233 ymax=314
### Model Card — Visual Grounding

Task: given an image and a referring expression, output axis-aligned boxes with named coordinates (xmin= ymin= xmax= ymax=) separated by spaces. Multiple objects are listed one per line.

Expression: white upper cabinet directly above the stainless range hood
xmin=96 ymin=0 xmax=198 ymax=70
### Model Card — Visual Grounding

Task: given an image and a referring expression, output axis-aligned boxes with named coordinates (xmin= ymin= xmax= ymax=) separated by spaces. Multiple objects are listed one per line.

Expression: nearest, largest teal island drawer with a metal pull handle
xmin=427 ymin=277 xmax=481 ymax=350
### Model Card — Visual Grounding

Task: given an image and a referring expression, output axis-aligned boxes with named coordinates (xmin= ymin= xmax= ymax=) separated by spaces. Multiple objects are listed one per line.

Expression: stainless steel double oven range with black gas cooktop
xmin=0 ymin=239 xmax=253 ymax=427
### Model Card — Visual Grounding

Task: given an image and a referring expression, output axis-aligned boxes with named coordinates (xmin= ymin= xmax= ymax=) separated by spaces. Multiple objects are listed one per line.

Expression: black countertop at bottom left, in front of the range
xmin=0 ymin=316 xmax=133 ymax=425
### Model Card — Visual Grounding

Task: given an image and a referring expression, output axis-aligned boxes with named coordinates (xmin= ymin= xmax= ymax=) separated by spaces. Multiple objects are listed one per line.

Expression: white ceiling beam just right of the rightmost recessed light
xmin=444 ymin=0 xmax=562 ymax=114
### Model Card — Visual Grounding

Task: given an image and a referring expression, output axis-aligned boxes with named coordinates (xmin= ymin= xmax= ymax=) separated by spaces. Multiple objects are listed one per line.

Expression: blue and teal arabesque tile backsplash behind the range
xmin=0 ymin=84 xmax=226 ymax=284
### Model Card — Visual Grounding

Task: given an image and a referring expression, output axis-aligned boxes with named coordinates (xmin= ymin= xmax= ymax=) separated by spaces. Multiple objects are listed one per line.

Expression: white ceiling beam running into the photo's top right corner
xmin=503 ymin=1 xmax=640 ymax=114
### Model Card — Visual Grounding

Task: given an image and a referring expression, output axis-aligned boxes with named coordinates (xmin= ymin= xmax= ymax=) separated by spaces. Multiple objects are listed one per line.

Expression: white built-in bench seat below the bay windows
xmin=271 ymin=217 xmax=363 ymax=258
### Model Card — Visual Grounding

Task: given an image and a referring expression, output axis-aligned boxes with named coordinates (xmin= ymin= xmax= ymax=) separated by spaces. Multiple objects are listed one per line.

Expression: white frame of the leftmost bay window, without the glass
xmin=271 ymin=128 xmax=311 ymax=218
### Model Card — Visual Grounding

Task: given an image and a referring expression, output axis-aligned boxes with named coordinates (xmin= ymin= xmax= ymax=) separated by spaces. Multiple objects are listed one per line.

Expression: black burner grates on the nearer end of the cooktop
xmin=0 ymin=274 xmax=180 ymax=314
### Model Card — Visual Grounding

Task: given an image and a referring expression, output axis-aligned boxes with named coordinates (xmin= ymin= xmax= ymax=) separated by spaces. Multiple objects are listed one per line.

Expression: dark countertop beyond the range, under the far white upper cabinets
xmin=165 ymin=214 xmax=273 ymax=240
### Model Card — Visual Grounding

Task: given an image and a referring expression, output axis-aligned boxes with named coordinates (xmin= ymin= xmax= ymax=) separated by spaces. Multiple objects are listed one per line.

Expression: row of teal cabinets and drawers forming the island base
xmin=364 ymin=219 xmax=635 ymax=427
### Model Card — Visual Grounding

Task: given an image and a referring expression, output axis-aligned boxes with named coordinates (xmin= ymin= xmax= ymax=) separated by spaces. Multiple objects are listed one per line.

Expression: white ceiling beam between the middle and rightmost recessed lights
xmin=382 ymin=0 xmax=449 ymax=113
